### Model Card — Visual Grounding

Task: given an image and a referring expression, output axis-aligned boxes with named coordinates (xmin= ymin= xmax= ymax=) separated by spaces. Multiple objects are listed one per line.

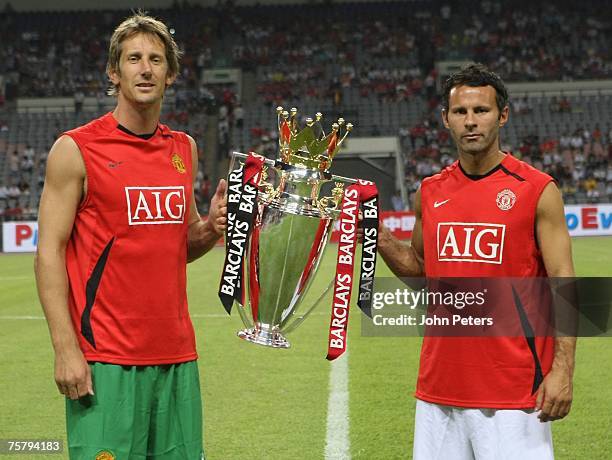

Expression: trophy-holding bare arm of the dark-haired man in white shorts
xmin=378 ymin=189 xmax=425 ymax=277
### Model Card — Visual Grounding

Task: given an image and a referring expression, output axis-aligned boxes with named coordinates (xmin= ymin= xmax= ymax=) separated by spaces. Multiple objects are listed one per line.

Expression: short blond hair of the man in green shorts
xmin=106 ymin=11 xmax=183 ymax=96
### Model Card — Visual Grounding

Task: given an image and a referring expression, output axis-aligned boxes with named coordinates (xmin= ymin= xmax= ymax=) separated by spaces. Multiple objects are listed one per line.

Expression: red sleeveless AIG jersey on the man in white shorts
xmin=416 ymin=154 xmax=554 ymax=408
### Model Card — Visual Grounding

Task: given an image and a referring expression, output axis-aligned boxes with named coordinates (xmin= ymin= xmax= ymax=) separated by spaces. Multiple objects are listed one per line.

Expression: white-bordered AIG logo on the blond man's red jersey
xmin=125 ymin=185 xmax=185 ymax=225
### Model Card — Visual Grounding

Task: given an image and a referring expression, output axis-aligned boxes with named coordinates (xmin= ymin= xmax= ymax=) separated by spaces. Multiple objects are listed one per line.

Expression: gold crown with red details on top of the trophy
xmin=276 ymin=106 xmax=353 ymax=171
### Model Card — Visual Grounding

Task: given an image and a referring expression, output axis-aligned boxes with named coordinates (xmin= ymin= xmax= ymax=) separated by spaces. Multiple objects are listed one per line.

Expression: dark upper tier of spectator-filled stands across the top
xmin=0 ymin=0 xmax=612 ymax=100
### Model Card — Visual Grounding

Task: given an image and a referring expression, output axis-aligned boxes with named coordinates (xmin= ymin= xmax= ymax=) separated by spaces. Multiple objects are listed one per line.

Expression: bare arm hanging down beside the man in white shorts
xmin=536 ymin=182 xmax=576 ymax=421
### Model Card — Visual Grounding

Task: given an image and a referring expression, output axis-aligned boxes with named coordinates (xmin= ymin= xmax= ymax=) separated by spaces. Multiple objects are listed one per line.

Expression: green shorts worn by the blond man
xmin=66 ymin=361 xmax=204 ymax=460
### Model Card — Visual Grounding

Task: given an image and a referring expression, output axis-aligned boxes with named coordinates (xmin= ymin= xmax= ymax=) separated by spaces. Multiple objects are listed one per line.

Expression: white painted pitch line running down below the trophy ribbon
xmin=325 ymin=350 xmax=351 ymax=460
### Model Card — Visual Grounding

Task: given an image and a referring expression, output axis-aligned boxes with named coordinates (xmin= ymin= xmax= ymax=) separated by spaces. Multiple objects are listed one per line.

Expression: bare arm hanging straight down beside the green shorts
xmin=34 ymin=136 xmax=93 ymax=399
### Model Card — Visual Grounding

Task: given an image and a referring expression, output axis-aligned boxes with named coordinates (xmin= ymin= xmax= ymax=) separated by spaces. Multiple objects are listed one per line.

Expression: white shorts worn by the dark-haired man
xmin=413 ymin=400 xmax=554 ymax=460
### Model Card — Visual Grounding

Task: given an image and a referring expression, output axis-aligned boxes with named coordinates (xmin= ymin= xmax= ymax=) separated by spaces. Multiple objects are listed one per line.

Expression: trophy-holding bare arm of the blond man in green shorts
xmin=187 ymin=136 xmax=227 ymax=262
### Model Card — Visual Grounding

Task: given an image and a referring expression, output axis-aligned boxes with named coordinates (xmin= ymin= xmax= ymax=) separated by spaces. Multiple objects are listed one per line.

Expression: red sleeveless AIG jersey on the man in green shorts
xmin=65 ymin=113 xmax=197 ymax=365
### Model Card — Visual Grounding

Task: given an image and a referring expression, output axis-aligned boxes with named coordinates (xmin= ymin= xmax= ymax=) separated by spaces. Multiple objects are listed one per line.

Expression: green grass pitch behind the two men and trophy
xmin=0 ymin=237 xmax=612 ymax=460
